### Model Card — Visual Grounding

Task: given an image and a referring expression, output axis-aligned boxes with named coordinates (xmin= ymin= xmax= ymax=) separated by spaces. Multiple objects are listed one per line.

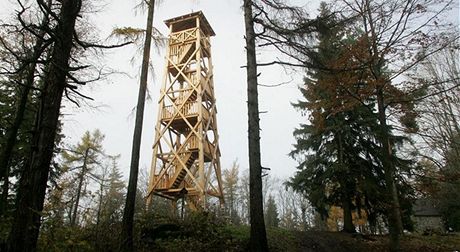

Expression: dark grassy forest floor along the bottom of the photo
xmin=30 ymin=211 xmax=460 ymax=252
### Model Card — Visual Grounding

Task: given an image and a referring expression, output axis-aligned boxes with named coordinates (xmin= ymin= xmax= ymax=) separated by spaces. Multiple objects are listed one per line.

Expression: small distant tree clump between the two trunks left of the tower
xmin=39 ymin=130 xmax=125 ymax=251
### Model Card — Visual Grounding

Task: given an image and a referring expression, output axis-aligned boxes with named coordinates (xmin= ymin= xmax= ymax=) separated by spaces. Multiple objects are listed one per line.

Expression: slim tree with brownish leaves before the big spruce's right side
xmin=336 ymin=0 xmax=455 ymax=247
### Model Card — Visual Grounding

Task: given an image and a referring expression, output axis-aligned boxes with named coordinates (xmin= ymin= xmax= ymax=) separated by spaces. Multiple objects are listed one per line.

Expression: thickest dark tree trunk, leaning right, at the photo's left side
xmin=8 ymin=0 xmax=81 ymax=251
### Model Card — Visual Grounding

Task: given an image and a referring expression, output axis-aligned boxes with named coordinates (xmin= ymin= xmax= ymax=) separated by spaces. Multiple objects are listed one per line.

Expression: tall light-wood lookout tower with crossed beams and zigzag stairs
xmin=147 ymin=11 xmax=223 ymax=210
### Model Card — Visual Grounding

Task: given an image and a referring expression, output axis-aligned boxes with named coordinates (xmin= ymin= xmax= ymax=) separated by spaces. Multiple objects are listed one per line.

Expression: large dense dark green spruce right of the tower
xmin=288 ymin=3 xmax=416 ymax=231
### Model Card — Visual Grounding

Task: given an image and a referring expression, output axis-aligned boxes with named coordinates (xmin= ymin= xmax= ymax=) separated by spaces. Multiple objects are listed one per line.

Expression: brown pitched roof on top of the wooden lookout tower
xmin=164 ymin=11 xmax=216 ymax=36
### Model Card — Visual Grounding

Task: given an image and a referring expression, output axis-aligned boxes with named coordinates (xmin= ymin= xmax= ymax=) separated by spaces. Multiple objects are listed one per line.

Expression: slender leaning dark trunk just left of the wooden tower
xmin=120 ymin=0 xmax=155 ymax=251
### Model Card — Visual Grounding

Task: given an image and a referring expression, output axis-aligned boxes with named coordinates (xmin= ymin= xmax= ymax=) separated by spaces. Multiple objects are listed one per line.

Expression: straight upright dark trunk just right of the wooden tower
xmin=244 ymin=0 xmax=268 ymax=251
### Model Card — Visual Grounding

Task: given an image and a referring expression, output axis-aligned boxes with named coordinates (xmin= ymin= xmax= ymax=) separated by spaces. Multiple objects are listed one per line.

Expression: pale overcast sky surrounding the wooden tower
xmin=0 ymin=0 xmax=322 ymax=181
